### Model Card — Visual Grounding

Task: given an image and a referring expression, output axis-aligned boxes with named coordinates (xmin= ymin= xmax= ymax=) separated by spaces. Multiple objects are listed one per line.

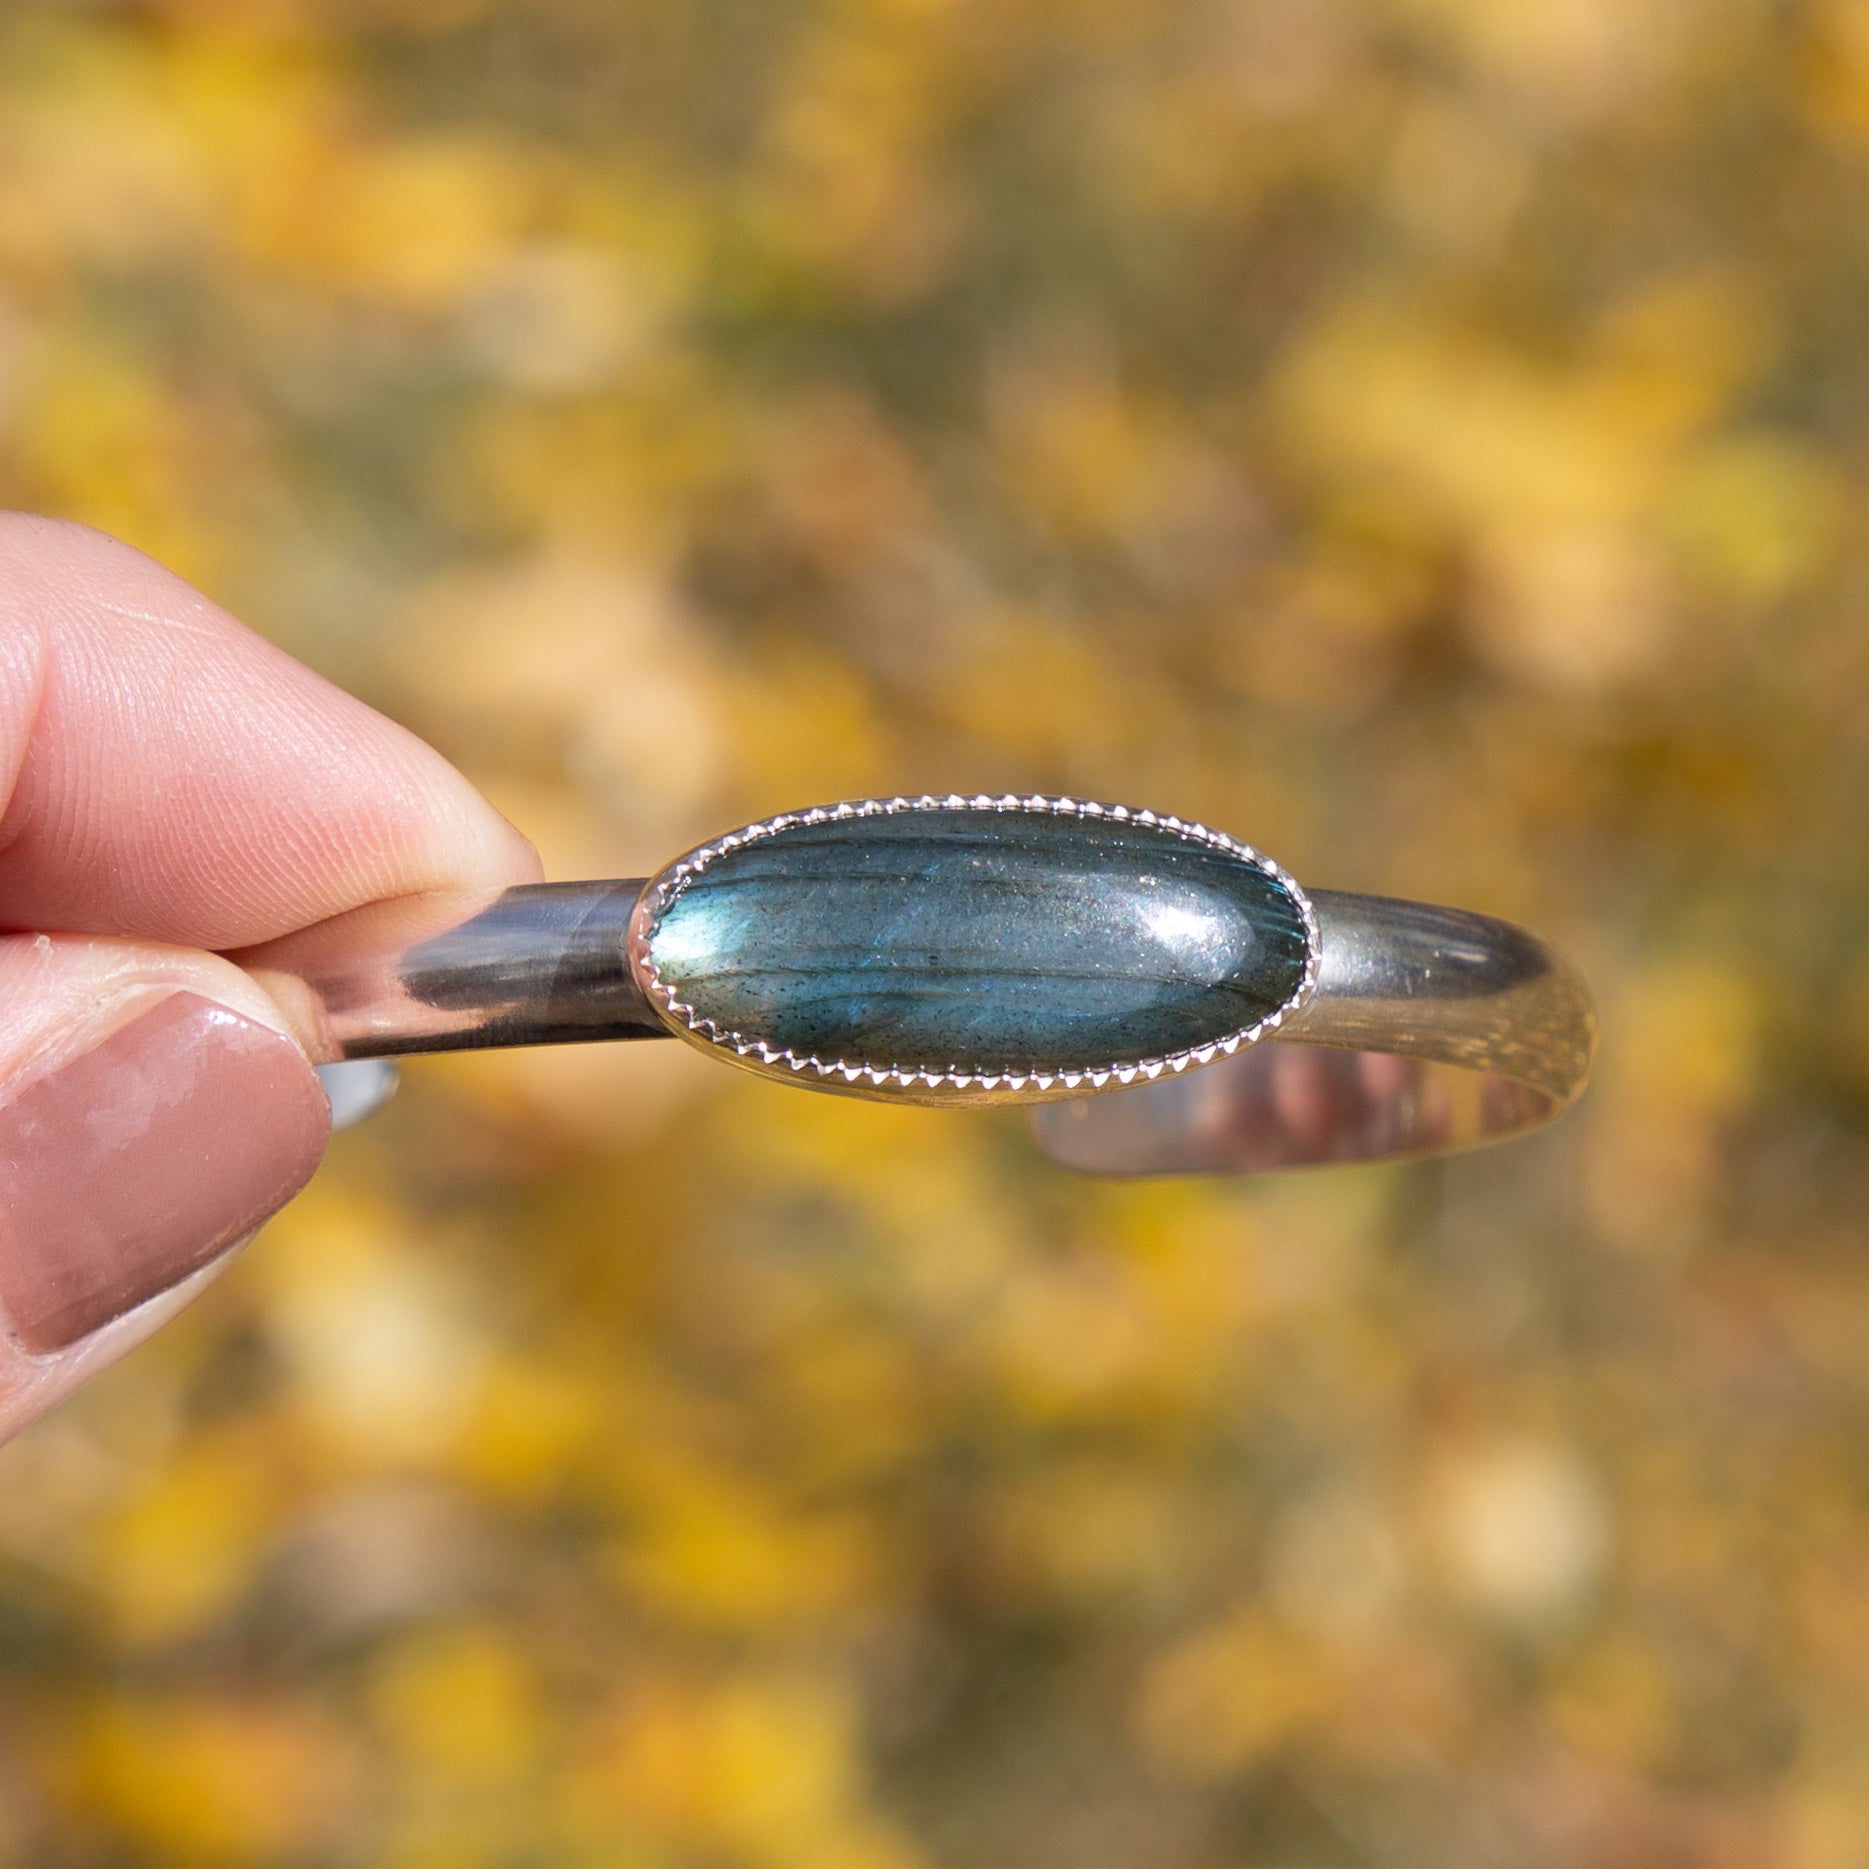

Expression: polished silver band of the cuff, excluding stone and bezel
xmin=265 ymin=878 xmax=1596 ymax=1174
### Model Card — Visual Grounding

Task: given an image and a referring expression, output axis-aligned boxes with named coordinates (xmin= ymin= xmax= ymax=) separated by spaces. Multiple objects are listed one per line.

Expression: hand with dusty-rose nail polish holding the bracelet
xmin=0 ymin=514 xmax=538 ymax=1437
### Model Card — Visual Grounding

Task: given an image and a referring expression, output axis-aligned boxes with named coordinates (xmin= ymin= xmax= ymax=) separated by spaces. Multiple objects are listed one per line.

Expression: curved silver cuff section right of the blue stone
xmin=1032 ymin=890 xmax=1596 ymax=1174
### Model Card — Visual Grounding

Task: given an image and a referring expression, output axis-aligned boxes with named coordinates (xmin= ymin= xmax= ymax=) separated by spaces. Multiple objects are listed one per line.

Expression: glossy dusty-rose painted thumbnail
xmin=0 ymin=992 xmax=331 ymax=1351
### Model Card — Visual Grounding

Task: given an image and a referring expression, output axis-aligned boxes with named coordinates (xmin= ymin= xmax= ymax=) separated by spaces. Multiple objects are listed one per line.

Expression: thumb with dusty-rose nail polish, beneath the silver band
xmin=0 ymin=935 xmax=331 ymax=1435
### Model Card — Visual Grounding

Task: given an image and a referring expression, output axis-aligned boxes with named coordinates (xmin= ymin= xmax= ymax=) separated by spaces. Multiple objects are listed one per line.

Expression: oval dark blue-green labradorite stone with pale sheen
xmin=649 ymin=809 xmax=1305 ymax=1073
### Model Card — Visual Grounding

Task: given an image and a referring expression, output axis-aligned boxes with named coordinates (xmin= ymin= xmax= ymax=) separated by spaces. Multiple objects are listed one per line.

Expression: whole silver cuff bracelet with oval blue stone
xmin=277 ymin=794 xmax=1596 ymax=1174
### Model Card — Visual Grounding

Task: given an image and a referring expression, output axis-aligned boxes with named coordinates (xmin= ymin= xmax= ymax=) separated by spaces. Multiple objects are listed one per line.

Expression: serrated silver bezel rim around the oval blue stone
xmin=628 ymin=792 xmax=1321 ymax=1103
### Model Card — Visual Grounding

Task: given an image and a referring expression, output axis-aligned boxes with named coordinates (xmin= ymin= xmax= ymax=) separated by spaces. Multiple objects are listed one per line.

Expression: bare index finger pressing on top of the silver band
xmin=0 ymin=514 xmax=538 ymax=951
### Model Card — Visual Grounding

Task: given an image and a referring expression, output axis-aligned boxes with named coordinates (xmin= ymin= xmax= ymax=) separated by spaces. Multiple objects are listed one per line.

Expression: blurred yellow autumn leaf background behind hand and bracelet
xmin=0 ymin=0 xmax=1869 ymax=1869
